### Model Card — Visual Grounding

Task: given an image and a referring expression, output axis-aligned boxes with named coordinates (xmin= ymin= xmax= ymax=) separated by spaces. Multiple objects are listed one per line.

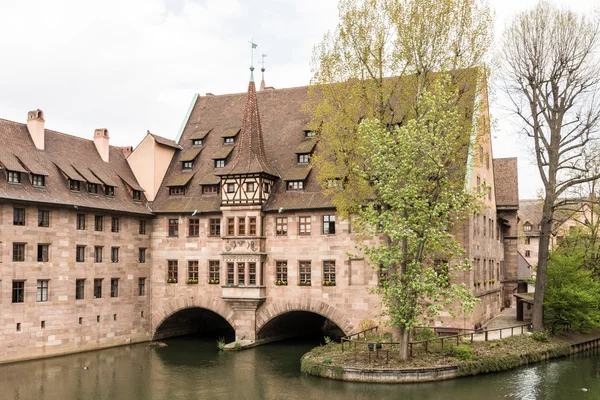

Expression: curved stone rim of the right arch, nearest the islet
xmin=256 ymin=298 xmax=354 ymax=337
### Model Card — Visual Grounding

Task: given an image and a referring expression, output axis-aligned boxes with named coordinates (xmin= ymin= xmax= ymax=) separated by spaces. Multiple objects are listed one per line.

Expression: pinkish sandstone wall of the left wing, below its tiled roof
xmin=0 ymin=202 xmax=151 ymax=363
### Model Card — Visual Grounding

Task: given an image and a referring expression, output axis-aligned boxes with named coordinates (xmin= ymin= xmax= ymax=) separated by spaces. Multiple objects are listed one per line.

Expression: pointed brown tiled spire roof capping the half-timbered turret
xmin=217 ymin=67 xmax=278 ymax=177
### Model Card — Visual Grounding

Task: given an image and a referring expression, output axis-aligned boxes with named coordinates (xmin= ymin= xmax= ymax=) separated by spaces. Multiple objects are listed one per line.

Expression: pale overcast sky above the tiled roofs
xmin=0 ymin=0 xmax=598 ymax=198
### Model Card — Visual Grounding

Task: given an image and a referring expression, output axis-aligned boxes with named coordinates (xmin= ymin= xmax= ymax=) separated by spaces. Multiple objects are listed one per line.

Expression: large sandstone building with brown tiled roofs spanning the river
xmin=0 ymin=70 xmax=518 ymax=362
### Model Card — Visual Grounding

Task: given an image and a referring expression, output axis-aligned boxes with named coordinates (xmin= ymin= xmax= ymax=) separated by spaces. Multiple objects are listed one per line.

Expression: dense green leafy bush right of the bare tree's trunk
xmin=544 ymin=247 xmax=600 ymax=332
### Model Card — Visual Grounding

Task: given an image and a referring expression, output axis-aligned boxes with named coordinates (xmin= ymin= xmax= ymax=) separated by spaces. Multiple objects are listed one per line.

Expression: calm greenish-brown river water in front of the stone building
xmin=0 ymin=337 xmax=600 ymax=400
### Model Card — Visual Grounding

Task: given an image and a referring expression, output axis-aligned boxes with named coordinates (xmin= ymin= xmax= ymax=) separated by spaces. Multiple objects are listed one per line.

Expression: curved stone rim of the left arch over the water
xmin=152 ymin=296 xmax=237 ymax=339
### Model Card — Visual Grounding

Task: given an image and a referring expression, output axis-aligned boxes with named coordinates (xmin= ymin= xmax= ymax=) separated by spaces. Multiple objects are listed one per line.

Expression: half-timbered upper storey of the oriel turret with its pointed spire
xmin=213 ymin=67 xmax=278 ymax=205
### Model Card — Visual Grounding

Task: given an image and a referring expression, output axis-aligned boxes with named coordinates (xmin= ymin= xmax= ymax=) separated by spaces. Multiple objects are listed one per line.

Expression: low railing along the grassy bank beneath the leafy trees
xmin=341 ymin=323 xmax=531 ymax=362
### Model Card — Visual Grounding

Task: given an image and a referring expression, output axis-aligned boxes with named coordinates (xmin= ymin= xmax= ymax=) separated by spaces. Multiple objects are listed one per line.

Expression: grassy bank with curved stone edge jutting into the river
xmin=301 ymin=332 xmax=584 ymax=383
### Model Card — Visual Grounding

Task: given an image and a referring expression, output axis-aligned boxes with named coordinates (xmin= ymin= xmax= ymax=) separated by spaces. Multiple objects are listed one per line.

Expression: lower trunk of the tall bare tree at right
xmin=531 ymin=195 xmax=554 ymax=332
